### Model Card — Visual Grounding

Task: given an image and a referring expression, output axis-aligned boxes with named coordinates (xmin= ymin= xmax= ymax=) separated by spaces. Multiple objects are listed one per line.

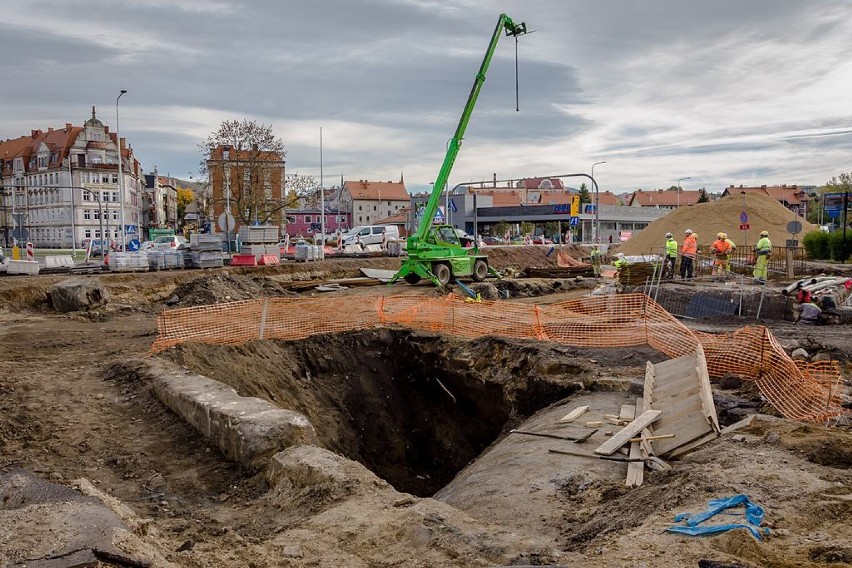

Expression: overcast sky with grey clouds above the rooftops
xmin=0 ymin=0 xmax=852 ymax=192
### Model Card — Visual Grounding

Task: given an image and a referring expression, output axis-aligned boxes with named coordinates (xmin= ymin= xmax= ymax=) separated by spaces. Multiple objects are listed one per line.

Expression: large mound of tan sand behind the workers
xmin=618 ymin=194 xmax=817 ymax=255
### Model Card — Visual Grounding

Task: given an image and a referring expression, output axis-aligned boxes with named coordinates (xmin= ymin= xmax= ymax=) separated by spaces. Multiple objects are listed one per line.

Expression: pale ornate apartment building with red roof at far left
xmin=0 ymin=107 xmax=144 ymax=248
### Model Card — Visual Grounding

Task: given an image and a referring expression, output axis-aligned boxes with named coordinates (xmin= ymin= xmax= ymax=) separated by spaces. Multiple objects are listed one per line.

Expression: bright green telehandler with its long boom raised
xmin=391 ymin=14 xmax=527 ymax=287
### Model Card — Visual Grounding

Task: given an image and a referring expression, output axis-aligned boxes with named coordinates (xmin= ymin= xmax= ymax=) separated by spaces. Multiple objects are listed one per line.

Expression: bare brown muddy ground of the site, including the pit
xmin=0 ymin=254 xmax=852 ymax=567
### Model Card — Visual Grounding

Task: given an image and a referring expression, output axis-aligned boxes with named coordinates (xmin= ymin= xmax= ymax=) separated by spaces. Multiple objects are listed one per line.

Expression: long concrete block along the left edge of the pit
xmin=115 ymin=358 xmax=317 ymax=472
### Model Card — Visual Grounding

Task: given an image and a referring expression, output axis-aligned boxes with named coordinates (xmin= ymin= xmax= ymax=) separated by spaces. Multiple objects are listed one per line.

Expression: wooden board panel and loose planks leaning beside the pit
xmin=560 ymin=345 xmax=721 ymax=487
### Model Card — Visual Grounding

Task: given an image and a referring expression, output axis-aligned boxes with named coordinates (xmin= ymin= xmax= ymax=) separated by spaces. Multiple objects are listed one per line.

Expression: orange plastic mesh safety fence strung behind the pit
xmin=151 ymin=294 xmax=844 ymax=422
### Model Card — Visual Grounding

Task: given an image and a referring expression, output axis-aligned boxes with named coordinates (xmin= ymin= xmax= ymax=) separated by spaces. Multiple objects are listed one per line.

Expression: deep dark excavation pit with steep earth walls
xmin=164 ymin=329 xmax=589 ymax=496
